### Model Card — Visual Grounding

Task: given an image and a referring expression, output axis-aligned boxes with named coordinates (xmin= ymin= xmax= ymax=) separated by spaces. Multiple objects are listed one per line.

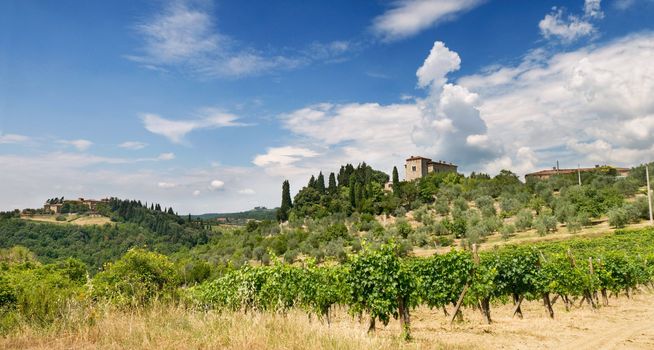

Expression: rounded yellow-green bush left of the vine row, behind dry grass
xmin=93 ymin=248 xmax=180 ymax=306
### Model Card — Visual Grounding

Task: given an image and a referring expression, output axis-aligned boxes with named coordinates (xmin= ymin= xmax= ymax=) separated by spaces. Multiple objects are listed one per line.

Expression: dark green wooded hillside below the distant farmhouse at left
xmin=0 ymin=198 xmax=215 ymax=270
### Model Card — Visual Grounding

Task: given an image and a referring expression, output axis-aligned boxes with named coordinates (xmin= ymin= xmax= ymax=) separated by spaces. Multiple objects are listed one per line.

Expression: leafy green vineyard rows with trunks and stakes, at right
xmin=192 ymin=229 xmax=654 ymax=339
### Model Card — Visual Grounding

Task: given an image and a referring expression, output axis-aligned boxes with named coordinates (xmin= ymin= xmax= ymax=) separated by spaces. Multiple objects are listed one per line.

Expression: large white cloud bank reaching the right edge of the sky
xmin=459 ymin=33 xmax=654 ymax=166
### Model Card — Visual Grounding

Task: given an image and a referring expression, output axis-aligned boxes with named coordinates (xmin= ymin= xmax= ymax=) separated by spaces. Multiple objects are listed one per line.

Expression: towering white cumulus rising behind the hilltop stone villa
xmin=254 ymin=42 xmax=501 ymax=181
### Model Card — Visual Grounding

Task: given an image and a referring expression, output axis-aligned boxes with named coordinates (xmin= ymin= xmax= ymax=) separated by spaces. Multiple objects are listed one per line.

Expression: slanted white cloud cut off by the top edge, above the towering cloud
xmin=372 ymin=0 xmax=484 ymax=41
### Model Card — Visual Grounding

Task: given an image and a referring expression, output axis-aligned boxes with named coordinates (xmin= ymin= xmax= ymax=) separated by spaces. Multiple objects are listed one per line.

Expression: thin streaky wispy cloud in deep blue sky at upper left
xmin=126 ymin=1 xmax=352 ymax=78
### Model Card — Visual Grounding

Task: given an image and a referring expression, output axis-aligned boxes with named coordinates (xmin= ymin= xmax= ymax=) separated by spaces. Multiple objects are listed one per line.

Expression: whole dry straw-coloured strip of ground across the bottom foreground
xmin=0 ymin=291 xmax=654 ymax=350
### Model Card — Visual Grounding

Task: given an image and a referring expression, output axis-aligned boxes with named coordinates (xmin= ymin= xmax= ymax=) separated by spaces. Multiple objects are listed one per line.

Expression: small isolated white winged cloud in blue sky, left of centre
xmin=141 ymin=108 xmax=245 ymax=143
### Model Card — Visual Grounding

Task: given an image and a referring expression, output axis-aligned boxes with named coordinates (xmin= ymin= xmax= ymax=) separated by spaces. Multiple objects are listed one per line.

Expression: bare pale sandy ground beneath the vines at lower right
xmin=330 ymin=292 xmax=654 ymax=350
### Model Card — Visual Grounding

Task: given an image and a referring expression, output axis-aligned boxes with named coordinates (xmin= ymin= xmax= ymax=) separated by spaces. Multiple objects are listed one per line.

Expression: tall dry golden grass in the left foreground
xmin=0 ymin=305 xmax=426 ymax=349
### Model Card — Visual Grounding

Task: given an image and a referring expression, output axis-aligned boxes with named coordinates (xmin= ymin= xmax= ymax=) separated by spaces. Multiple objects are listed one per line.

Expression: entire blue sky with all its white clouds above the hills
xmin=0 ymin=0 xmax=654 ymax=214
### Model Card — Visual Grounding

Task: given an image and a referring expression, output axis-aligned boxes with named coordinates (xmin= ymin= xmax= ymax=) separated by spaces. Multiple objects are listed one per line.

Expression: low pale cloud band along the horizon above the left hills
xmin=0 ymin=152 xmax=284 ymax=214
